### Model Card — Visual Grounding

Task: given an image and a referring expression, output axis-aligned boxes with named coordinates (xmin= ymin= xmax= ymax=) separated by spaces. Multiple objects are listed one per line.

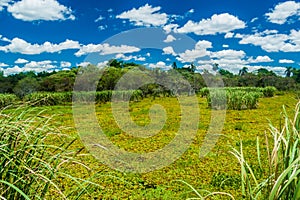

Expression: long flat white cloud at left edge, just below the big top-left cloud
xmin=0 ymin=38 xmax=80 ymax=55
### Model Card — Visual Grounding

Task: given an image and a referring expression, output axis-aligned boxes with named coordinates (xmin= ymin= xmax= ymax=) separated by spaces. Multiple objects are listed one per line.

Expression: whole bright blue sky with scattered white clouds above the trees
xmin=0 ymin=0 xmax=300 ymax=75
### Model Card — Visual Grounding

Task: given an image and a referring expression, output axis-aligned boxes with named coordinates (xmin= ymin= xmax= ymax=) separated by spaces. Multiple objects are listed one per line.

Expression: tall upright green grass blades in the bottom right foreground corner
xmin=232 ymin=102 xmax=300 ymax=200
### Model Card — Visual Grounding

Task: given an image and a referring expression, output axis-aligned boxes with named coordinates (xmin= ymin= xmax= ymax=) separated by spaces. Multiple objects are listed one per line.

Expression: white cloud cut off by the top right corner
xmin=266 ymin=1 xmax=300 ymax=24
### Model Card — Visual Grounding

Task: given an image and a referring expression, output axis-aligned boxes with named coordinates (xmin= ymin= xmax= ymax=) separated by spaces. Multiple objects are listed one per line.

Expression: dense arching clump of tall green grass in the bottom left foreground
xmin=0 ymin=106 xmax=95 ymax=199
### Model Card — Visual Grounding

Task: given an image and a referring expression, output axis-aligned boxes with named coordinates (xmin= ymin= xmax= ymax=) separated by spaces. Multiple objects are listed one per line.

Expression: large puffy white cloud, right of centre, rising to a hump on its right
xmin=177 ymin=13 xmax=246 ymax=35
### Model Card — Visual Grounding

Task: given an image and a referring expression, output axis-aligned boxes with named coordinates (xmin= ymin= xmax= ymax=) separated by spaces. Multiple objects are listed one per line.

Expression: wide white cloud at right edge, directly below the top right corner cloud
xmin=239 ymin=30 xmax=300 ymax=52
